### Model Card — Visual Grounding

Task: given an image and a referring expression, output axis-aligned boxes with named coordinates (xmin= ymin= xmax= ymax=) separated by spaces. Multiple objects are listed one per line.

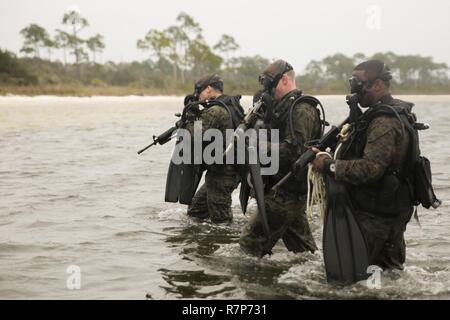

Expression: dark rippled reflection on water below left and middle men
xmin=159 ymin=216 xmax=298 ymax=299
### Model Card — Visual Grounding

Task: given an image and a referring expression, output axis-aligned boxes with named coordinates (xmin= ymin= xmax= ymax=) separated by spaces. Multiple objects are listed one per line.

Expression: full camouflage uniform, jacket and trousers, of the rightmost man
xmin=335 ymin=95 xmax=413 ymax=269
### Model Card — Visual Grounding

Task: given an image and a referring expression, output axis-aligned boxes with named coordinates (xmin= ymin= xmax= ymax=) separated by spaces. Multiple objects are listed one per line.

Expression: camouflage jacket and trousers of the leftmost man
xmin=186 ymin=97 xmax=240 ymax=223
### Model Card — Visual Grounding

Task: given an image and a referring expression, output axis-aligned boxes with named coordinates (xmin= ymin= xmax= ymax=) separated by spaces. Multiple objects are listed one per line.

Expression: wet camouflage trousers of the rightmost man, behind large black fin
xmin=355 ymin=208 xmax=413 ymax=270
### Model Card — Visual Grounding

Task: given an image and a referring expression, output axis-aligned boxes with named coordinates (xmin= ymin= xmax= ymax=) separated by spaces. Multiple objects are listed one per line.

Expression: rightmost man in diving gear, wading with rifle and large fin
xmin=312 ymin=60 xmax=441 ymax=283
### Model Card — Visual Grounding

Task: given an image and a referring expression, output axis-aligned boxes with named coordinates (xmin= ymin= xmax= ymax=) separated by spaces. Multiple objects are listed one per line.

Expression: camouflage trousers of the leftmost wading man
xmin=187 ymin=171 xmax=240 ymax=223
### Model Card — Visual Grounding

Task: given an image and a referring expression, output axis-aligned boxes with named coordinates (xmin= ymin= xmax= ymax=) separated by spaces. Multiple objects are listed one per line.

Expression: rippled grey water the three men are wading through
xmin=0 ymin=96 xmax=450 ymax=299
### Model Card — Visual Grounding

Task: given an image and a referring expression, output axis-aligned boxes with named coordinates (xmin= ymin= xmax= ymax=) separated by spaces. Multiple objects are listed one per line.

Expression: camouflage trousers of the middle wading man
xmin=239 ymin=190 xmax=317 ymax=257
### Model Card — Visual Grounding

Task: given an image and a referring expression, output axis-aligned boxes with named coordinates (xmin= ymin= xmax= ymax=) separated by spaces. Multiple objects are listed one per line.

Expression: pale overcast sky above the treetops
xmin=0 ymin=0 xmax=450 ymax=70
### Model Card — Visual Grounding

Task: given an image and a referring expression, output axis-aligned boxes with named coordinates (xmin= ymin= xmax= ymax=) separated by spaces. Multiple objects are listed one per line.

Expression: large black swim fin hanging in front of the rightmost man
xmin=323 ymin=177 xmax=369 ymax=284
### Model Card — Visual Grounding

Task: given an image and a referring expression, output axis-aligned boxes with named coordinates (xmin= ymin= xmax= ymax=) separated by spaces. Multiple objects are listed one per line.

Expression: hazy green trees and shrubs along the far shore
xmin=0 ymin=11 xmax=450 ymax=96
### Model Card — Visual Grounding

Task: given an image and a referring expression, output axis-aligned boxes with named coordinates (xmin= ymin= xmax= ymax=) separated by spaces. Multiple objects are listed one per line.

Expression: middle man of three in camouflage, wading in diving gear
xmin=239 ymin=60 xmax=323 ymax=257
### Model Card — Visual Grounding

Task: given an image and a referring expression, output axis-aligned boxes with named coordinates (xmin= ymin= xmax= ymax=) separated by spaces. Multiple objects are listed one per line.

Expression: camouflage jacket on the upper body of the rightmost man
xmin=335 ymin=95 xmax=413 ymax=217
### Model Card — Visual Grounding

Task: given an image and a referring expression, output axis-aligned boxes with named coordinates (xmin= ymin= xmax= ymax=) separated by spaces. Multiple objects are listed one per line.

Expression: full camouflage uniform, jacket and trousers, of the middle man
xmin=239 ymin=90 xmax=320 ymax=257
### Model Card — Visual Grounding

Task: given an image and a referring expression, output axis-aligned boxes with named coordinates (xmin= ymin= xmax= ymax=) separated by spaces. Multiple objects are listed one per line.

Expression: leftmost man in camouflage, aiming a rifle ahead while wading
xmin=140 ymin=74 xmax=244 ymax=223
